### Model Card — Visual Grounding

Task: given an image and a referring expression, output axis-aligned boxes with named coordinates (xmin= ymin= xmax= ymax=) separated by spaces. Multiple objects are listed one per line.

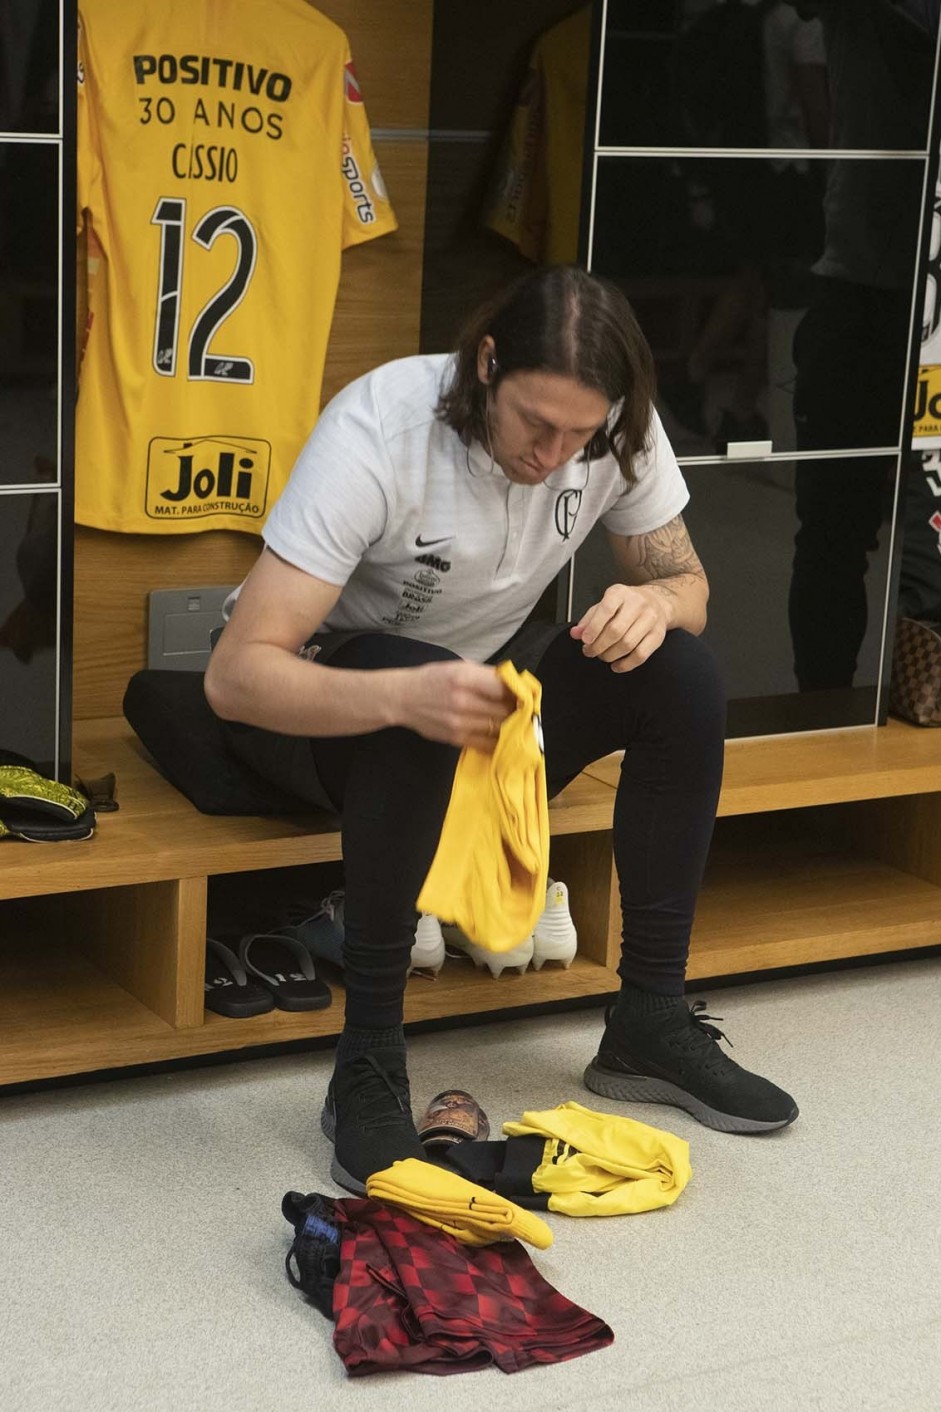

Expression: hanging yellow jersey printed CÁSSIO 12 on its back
xmin=75 ymin=0 xmax=396 ymax=534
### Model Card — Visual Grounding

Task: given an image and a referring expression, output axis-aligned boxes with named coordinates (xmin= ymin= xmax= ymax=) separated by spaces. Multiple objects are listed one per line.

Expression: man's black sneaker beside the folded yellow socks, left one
xmin=321 ymin=1048 xmax=427 ymax=1196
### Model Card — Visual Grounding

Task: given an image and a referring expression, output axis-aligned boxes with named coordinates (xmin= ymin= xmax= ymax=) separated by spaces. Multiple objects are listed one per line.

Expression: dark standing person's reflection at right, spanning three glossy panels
xmin=788 ymin=0 xmax=940 ymax=690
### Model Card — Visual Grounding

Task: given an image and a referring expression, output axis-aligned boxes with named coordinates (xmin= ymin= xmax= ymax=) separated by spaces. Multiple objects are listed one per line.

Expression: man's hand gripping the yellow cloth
xmin=393 ymin=662 xmax=516 ymax=751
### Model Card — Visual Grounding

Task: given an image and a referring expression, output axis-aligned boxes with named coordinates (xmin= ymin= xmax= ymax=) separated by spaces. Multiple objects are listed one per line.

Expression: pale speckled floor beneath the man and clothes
xmin=0 ymin=960 xmax=941 ymax=1412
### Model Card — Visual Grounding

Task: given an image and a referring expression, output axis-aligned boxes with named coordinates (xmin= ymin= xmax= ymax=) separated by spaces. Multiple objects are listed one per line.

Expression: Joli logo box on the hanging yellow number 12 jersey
xmin=144 ymin=436 xmax=271 ymax=520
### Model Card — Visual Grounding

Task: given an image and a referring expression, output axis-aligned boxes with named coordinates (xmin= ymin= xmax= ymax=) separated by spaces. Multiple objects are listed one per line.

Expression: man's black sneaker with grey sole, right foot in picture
xmin=584 ymin=1000 xmax=797 ymax=1132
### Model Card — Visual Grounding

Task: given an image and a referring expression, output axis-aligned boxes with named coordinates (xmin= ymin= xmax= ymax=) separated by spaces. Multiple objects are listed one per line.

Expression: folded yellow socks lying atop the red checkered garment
xmin=366 ymin=1156 xmax=552 ymax=1250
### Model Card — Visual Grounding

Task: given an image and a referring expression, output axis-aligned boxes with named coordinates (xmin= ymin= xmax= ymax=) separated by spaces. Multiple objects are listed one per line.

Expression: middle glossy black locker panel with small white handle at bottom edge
xmin=592 ymin=157 xmax=924 ymax=456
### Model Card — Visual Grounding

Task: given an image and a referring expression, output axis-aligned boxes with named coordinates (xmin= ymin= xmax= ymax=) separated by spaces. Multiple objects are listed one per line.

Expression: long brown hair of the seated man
xmin=437 ymin=265 xmax=657 ymax=486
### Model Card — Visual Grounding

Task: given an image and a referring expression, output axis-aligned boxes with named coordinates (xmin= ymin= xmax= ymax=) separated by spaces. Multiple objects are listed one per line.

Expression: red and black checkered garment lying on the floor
xmin=333 ymin=1197 xmax=615 ymax=1374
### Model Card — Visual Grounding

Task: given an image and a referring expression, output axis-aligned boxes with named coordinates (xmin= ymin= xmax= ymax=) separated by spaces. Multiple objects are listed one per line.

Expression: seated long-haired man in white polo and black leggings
xmin=206 ymin=265 xmax=797 ymax=1190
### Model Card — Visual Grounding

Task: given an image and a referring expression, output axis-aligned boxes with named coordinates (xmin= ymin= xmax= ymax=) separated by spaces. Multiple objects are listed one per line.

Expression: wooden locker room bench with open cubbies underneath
xmin=0 ymin=717 xmax=941 ymax=1084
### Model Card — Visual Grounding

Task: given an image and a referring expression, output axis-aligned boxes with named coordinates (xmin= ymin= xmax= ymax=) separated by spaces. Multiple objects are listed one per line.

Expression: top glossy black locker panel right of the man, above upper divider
xmin=600 ymin=0 xmax=937 ymax=151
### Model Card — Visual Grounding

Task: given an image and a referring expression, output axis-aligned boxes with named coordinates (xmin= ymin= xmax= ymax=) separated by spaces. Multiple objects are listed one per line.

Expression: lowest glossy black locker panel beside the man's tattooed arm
xmin=574 ymin=456 xmax=896 ymax=737
